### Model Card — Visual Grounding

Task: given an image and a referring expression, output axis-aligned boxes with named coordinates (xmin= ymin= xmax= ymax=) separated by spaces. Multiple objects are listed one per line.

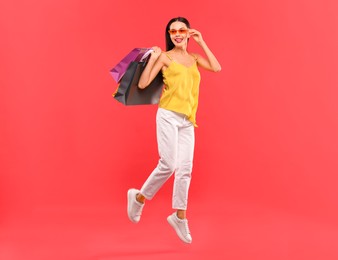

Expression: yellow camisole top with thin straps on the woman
xmin=159 ymin=54 xmax=201 ymax=127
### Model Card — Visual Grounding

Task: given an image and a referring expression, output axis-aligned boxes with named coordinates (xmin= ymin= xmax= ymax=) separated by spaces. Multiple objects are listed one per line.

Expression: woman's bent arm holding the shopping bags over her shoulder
xmin=138 ymin=47 xmax=164 ymax=89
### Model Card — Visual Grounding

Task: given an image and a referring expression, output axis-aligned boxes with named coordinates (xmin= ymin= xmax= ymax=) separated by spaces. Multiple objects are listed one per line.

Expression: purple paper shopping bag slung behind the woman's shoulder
xmin=110 ymin=48 xmax=153 ymax=83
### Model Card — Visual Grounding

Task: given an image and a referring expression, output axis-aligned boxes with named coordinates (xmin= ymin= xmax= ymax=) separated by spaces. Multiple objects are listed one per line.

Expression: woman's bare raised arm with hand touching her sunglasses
xmin=189 ymin=29 xmax=221 ymax=72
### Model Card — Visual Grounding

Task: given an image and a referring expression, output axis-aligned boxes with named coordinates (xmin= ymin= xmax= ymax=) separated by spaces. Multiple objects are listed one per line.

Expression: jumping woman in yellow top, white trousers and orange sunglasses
xmin=128 ymin=17 xmax=221 ymax=243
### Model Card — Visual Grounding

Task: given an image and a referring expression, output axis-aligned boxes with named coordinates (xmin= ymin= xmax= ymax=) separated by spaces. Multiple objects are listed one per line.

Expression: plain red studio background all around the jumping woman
xmin=0 ymin=0 xmax=338 ymax=260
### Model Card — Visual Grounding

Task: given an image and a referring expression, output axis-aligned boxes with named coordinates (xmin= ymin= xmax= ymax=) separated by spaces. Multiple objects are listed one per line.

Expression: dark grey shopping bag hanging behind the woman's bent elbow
xmin=113 ymin=57 xmax=163 ymax=106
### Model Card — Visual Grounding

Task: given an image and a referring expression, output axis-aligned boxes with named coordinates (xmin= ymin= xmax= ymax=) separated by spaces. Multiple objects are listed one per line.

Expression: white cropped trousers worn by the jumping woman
xmin=140 ymin=108 xmax=195 ymax=210
